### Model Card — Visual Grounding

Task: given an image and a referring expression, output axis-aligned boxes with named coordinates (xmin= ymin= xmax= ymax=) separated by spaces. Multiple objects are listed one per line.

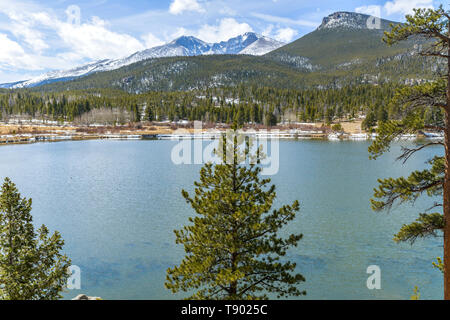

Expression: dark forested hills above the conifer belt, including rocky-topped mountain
xmin=5 ymin=12 xmax=441 ymax=93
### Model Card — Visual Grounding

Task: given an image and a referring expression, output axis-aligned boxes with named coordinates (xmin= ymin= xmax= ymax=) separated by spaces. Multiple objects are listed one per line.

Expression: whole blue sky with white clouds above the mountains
xmin=0 ymin=0 xmax=440 ymax=83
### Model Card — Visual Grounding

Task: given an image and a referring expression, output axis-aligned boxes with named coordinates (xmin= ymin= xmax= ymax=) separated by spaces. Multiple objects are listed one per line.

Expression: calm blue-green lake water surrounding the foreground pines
xmin=0 ymin=141 xmax=443 ymax=299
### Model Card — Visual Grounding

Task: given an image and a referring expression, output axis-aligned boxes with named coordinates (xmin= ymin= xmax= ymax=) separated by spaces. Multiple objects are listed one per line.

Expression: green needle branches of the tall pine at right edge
xmin=369 ymin=7 xmax=448 ymax=249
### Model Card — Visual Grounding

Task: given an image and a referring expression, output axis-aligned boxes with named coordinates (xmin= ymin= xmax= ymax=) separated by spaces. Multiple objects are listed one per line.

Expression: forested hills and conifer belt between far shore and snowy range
xmin=0 ymin=12 xmax=444 ymax=127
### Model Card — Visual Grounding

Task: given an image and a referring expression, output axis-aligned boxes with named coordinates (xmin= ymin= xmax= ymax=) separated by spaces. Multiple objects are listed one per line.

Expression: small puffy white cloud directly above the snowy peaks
xmin=194 ymin=18 xmax=253 ymax=42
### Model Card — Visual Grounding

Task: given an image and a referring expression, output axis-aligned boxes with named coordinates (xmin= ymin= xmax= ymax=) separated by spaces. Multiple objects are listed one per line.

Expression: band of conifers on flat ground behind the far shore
xmin=0 ymin=84 xmax=441 ymax=127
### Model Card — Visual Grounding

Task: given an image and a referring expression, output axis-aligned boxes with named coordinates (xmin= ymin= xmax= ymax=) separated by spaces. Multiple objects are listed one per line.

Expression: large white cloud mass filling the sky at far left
xmin=0 ymin=0 xmax=146 ymax=70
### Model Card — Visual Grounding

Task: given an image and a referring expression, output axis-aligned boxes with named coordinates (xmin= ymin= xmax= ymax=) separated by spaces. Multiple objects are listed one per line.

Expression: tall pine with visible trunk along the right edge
xmin=369 ymin=6 xmax=450 ymax=300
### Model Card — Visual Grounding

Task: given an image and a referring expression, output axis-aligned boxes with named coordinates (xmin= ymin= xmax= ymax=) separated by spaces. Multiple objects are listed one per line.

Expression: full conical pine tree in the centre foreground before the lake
xmin=166 ymin=131 xmax=305 ymax=300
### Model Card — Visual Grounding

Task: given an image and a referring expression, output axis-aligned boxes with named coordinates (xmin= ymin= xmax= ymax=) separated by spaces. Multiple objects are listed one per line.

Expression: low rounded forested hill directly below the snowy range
xmin=34 ymin=55 xmax=305 ymax=93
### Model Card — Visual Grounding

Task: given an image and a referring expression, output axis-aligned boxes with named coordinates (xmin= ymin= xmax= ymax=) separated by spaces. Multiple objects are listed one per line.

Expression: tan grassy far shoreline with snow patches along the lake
xmin=0 ymin=122 xmax=443 ymax=145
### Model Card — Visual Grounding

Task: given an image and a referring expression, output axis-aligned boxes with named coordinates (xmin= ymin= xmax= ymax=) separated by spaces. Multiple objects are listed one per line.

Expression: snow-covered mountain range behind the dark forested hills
xmin=0 ymin=32 xmax=284 ymax=88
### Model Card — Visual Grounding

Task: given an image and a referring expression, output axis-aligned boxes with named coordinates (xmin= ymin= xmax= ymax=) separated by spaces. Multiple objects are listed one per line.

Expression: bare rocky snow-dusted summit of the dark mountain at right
xmin=317 ymin=11 xmax=378 ymax=30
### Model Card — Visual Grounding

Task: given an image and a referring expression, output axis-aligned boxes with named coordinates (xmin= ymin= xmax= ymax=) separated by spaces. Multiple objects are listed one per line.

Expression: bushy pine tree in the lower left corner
xmin=0 ymin=178 xmax=70 ymax=300
